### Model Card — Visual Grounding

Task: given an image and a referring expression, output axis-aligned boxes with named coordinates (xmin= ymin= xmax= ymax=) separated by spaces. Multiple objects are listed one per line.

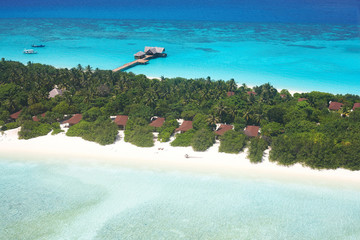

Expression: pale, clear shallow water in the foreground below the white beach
xmin=0 ymin=158 xmax=360 ymax=240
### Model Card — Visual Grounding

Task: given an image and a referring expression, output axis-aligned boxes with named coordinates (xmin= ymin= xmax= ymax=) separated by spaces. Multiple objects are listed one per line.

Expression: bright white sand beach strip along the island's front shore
xmin=0 ymin=128 xmax=360 ymax=187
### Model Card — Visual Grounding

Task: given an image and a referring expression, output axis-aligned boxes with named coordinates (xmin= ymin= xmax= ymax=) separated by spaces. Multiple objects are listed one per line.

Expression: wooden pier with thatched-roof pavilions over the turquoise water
xmin=113 ymin=47 xmax=167 ymax=72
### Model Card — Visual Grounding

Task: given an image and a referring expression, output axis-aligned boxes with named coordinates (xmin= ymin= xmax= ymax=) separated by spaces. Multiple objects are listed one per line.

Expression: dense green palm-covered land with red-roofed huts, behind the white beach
xmin=0 ymin=59 xmax=360 ymax=170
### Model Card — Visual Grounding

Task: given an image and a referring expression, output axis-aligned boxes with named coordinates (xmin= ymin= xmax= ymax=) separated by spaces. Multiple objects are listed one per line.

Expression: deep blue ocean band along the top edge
xmin=0 ymin=0 xmax=360 ymax=24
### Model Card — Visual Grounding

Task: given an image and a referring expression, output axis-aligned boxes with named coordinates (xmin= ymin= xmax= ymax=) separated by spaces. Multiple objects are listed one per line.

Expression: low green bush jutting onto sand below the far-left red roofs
xmin=19 ymin=120 xmax=52 ymax=139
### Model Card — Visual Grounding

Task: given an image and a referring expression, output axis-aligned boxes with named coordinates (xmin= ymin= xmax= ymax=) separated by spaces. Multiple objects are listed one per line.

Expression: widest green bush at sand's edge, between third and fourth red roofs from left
xmin=66 ymin=119 xmax=118 ymax=145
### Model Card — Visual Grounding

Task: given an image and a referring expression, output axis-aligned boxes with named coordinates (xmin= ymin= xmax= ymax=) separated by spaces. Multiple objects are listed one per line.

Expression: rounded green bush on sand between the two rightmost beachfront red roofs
xmin=219 ymin=130 xmax=246 ymax=153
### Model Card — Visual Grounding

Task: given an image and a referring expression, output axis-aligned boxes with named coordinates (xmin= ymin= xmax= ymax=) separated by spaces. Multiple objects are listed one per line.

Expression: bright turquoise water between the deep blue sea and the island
xmin=0 ymin=18 xmax=360 ymax=94
